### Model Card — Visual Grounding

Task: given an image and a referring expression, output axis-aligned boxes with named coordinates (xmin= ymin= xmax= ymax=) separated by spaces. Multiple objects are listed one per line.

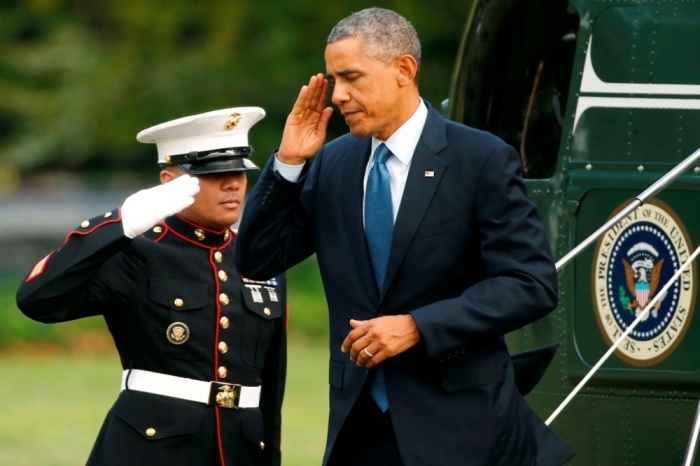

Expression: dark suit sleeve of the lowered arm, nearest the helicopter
xmin=411 ymin=145 xmax=557 ymax=358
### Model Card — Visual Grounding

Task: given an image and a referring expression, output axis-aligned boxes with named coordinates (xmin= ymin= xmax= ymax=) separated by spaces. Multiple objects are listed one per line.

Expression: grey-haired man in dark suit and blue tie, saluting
xmin=237 ymin=8 xmax=573 ymax=466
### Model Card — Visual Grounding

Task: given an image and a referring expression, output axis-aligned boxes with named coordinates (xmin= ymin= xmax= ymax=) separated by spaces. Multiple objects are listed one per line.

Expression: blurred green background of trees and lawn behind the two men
xmin=0 ymin=0 xmax=471 ymax=466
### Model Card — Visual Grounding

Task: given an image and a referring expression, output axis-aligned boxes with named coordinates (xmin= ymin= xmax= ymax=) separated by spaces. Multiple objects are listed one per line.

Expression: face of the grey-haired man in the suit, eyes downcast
xmin=325 ymin=37 xmax=403 ymax=140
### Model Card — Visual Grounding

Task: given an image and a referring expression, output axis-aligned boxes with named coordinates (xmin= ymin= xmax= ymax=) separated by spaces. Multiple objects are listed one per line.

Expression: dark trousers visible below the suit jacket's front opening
xmin=328 ymin=386 xmax=403 ymax=466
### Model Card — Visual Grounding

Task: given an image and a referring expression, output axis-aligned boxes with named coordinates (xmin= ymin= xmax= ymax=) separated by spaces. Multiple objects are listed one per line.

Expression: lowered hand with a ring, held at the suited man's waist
xmin=341 ymin=314 xmax=420 ymax=369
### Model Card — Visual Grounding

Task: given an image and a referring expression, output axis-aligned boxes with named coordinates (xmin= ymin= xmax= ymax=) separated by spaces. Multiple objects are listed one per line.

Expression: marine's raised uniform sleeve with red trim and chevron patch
xmin=17 ymin=209 xmax=131 ymax=323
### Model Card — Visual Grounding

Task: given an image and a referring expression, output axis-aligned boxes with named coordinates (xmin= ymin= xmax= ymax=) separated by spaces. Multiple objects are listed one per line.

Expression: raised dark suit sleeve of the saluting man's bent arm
xmin=236 ymin=149 xmax=323 ymax=280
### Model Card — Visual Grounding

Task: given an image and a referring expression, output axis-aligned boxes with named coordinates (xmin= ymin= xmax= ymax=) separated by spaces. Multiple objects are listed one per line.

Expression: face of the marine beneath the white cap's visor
xmin=167 ymin=172 xmax=248 ymax=229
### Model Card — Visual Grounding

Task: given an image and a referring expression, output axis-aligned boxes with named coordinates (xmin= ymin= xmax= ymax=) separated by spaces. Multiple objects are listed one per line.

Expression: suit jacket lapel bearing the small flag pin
xmin=380 ymin=106 xmax=447 ymax=299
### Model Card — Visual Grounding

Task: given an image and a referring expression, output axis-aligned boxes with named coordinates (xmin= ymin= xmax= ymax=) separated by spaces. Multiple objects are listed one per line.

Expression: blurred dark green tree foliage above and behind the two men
xmin=0 ymin=0 xmax=470 ymax=175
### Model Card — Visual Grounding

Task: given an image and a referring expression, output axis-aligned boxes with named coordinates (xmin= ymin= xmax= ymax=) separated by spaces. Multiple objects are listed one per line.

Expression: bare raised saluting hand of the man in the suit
xmin=277 ymin=73 xmax=333 ymax=165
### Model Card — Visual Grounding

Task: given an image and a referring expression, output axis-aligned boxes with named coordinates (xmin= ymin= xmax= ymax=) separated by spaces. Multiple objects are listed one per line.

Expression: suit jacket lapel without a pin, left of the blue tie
xmin=341 ymin=138 xmax=379 ymax=303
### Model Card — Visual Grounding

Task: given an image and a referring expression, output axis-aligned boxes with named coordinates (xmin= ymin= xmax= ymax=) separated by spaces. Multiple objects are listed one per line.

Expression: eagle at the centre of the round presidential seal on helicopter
xmin=620 ymin=242 xmax=664 ymax=320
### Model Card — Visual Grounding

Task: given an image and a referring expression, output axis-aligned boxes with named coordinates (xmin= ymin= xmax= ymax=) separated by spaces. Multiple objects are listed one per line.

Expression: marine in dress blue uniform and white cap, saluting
xmin=17 ymin=107 xmax=286 ymax=466
